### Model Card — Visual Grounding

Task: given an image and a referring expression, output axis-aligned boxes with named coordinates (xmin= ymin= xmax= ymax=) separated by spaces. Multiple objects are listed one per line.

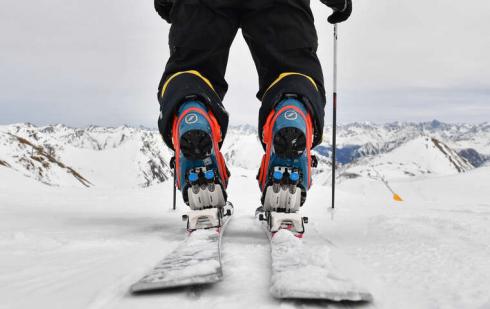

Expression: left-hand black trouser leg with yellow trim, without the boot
xmin=158 ymin=0 xmax=239 ymax=148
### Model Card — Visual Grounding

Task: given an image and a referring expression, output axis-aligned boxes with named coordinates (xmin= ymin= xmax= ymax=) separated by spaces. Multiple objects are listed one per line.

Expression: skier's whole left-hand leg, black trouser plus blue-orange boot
xmin=158 ymin=0 xmax=238 ymax=209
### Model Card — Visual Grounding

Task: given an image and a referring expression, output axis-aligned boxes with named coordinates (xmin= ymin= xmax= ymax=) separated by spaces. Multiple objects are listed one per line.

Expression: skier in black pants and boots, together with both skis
xmin=130 ymin=0 xmax=364 ymax=294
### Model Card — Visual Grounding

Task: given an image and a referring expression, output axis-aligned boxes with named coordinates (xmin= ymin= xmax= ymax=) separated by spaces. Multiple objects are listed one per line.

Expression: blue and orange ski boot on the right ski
xmin=256 ymin=95 xmax=316 ymax=237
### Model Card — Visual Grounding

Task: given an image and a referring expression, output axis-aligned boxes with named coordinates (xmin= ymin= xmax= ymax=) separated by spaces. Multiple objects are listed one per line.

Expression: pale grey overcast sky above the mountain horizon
xmin=0 ymin=0 xmax=490 ymax=127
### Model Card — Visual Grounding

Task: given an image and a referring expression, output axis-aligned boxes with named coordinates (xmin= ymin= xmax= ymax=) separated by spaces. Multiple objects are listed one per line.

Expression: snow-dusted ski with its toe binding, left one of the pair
xmin=130 ymin=202 xmax=233 ymax=293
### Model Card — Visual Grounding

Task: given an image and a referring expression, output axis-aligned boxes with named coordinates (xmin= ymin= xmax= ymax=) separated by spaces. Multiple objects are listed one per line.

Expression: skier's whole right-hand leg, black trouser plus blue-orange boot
xmin=242 ymin=0 xmax=325 ymax=211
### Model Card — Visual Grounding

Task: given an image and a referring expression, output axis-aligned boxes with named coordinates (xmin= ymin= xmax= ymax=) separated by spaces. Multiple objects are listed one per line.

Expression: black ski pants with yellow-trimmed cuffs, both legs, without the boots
xmin=158 ymin=0 xmax=326 ymax=149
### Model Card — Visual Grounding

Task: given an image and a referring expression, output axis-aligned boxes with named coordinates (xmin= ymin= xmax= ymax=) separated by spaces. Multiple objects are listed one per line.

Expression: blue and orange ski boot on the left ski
xmin=172 ymin=100 xmax=232 ymax=231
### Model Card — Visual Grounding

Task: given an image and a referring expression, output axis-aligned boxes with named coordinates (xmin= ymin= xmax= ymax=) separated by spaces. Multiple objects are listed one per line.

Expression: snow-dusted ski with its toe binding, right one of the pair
xmin=256 ymin=207 xmax=372 ymax=302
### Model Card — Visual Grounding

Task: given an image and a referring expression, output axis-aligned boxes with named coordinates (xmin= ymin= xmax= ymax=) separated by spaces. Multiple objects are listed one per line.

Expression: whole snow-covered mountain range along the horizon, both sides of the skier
xmin=0 ymin=121 xmax=490 ymax=187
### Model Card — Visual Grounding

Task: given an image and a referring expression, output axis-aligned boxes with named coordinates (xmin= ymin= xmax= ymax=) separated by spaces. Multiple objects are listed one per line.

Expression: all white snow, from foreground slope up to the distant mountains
xmin=0 ymin=124 xmax=490 ymax=308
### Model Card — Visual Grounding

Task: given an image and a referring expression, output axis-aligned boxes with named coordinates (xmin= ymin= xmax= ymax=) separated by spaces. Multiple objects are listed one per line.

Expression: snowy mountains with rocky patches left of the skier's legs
xmin=0 ymin=124 xmax=172 ymax=187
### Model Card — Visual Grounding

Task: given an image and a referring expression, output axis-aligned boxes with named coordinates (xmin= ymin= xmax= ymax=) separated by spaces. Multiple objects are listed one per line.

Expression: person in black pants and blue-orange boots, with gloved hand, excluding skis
xmin=155 ymin=0 xmax=352 ymax=226
